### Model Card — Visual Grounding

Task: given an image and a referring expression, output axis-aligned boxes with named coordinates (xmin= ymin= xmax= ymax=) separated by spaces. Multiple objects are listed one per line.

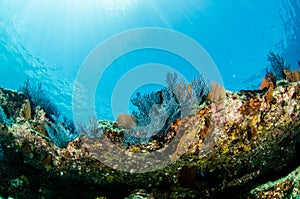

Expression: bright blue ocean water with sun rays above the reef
xmin=0 ymin=0 xmax=300 ymax=120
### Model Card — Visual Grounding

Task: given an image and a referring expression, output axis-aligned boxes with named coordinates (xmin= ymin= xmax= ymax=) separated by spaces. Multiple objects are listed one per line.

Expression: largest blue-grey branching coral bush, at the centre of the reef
xmin=127 ymin=73 xmax=210 ymax=144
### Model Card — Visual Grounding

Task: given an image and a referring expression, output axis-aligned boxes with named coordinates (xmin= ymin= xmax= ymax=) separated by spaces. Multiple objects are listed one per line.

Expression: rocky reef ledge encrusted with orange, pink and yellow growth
xmin=0 ymin=81 xmax=300 ymax=198
